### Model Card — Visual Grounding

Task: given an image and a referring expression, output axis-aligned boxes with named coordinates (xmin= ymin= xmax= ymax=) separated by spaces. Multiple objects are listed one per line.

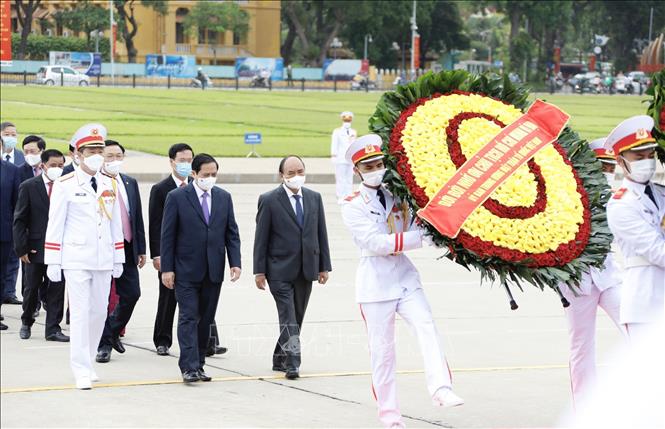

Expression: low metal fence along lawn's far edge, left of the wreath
xmin=0 ymin=72 xmax=392 ymax=92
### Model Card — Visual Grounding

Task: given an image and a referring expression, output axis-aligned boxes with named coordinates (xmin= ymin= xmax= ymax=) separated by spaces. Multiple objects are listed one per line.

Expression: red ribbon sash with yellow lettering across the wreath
xmin=418 ymin=100 xmax=570 ymax=238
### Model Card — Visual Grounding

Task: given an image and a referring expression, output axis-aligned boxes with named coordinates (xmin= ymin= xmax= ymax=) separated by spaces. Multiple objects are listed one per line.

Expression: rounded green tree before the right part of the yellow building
xmin=183 ymin=2 xmax=249 ymax=61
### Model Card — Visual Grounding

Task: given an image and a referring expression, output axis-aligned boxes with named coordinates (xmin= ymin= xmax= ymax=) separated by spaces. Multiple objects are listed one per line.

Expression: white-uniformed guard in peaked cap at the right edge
xmin=605 ymin=115 xmax=665 ymax=337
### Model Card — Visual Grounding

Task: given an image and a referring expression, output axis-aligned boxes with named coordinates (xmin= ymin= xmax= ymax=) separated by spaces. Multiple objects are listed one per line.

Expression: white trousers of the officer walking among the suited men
xmin=63 ymin=270 xmax=111 ymax=380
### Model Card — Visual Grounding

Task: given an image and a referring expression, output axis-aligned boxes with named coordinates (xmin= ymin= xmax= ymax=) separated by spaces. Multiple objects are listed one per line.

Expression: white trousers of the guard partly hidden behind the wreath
xmin=561 ymin=286 xmax=626 ymax=404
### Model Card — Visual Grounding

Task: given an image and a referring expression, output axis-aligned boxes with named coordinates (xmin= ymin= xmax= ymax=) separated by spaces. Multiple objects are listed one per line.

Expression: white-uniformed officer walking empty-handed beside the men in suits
xmin=44 ymin=124 xmax=125 ymax=389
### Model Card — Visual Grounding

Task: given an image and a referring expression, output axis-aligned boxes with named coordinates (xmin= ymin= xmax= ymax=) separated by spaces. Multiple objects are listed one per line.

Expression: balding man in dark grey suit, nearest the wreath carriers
xmin=254 ymin=156 xmax=332 ymax=380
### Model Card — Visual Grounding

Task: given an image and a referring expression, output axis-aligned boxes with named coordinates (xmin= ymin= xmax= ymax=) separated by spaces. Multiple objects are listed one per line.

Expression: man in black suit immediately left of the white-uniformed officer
xmin=13 ymin=149 xmax=69 ymax=342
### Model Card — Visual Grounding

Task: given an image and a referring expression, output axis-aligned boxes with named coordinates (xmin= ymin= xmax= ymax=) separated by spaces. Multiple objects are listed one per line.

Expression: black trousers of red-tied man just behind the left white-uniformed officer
xmin=98 ymin=241 xmax=141 ymax=350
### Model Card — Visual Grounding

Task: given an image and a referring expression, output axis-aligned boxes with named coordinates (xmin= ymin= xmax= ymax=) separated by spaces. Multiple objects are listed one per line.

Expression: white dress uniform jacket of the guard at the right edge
xmin=607 ymin=179 xmax=665 ymax=323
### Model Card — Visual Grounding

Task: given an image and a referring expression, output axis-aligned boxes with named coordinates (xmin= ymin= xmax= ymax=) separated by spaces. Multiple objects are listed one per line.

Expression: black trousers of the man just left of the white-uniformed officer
xmin=21 ymin=262 xmax=65 ymax=337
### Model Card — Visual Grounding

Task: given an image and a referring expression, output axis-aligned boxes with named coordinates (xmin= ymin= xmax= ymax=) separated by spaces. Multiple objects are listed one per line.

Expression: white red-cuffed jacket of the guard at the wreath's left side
xmin=342 ymin=185 xmax=423 ymax=304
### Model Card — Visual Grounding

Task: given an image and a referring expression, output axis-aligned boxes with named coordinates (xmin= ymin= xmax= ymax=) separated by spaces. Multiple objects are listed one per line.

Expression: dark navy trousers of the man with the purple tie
xmin=175 ymin=273 xmax=222 ymax=372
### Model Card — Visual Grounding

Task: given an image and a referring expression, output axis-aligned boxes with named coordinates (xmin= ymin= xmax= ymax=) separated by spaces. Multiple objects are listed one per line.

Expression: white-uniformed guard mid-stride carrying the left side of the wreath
xmin=342 ymin=134 xmax=464 ymax=427
